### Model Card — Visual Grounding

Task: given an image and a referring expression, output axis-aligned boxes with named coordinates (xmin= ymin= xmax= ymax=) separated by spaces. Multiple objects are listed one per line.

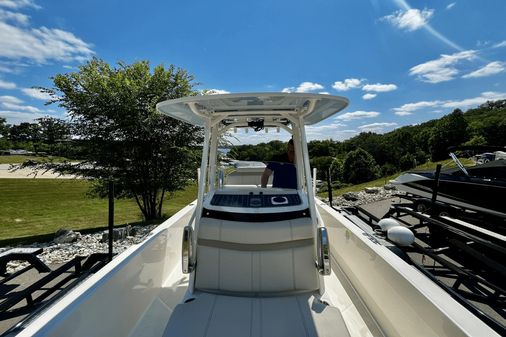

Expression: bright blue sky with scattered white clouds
xmin=0 ymin=0 xmax=506 ymax=142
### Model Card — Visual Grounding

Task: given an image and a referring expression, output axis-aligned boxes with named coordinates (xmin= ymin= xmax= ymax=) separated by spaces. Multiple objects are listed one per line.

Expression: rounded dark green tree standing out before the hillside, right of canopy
xmin=343 ymin=148 xmax=379 ymax=184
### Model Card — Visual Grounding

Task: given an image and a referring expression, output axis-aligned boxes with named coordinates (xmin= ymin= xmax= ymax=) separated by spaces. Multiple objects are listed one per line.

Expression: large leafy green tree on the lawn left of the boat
xmin=21 ymin=59 xmax=202 ymax=220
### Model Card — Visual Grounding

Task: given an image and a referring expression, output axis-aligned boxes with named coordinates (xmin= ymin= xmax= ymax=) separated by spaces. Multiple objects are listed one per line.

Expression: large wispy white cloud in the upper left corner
xmin=0 ymin=1 xmax=94 ymax=64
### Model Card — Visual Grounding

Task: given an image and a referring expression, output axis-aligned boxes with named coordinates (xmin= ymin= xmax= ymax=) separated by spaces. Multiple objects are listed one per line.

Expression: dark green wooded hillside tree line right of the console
xmin=230 ymin=100 xmax=506 ymax=185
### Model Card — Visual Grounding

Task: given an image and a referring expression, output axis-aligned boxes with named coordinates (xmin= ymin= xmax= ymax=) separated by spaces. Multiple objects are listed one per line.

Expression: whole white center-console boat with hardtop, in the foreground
xmin=10 ymin=93 xmax=498 ymax=337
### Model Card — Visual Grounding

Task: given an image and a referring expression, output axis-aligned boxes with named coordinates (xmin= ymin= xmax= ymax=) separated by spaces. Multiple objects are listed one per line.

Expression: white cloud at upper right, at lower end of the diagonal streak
xmin=409 ymin=50 xmax=477 ymax=83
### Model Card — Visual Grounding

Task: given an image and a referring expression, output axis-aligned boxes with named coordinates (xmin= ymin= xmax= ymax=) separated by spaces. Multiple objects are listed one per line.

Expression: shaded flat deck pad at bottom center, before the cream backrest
xmin=163 ymin=292 xmax=350 ymax=337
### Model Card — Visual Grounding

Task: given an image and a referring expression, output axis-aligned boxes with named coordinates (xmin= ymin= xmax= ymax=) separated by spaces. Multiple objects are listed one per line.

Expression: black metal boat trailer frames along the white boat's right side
xmin=339 ymin=204 xmax=506 ymax=336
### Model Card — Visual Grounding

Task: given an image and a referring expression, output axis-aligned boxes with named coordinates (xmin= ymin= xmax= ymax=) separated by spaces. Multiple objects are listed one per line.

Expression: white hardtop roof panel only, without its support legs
xmin=156 ymin=93 xmax=348 ymax=126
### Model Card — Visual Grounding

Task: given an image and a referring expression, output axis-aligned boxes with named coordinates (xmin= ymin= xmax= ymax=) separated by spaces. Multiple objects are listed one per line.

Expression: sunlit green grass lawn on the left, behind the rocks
xmin=0 ymin=179 xmax=197 ymax=240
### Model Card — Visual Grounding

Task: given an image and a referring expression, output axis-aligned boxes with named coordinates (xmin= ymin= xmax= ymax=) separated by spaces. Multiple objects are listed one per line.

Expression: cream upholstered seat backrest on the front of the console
xmin=195 ymin=217 xmax=319 ymax=293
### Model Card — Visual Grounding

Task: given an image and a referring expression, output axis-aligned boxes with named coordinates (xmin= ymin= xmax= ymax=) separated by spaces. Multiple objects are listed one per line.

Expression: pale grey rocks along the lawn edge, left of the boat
xmin=1 ymin=225 xmax=156 ymax=273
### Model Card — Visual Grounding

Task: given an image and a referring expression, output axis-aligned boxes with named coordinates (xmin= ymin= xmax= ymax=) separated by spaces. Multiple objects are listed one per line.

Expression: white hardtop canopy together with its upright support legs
xmin=156 ymin=93 xmax=348 ymax=230
